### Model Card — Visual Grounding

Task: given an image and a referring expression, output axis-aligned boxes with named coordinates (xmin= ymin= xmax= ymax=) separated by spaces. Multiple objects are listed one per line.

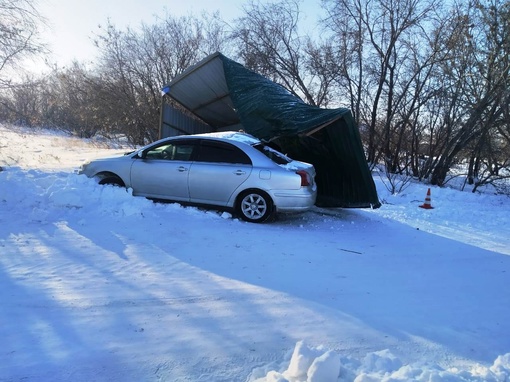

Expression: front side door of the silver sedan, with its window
xmin=131 ymin=140 xmax=195 ymax=202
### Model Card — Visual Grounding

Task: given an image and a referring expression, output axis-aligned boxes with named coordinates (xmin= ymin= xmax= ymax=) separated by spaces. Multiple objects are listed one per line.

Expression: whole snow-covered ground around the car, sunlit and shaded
xmin=0 ymin=125 xmax=510 ymax=382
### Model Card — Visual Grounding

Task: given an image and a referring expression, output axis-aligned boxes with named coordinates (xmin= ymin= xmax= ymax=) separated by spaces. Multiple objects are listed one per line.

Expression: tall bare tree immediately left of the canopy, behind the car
xmin=92 ymin=15 xmax=226 ymax=144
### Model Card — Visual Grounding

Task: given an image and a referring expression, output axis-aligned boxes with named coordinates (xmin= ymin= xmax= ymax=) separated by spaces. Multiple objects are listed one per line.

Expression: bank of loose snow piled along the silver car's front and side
xmin=0 ymin=167 xmax=232 ymax=227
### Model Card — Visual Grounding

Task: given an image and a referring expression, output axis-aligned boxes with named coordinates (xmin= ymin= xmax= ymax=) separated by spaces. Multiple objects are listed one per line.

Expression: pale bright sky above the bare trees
xmin=38 ymin=0 xmax=320 ymax=66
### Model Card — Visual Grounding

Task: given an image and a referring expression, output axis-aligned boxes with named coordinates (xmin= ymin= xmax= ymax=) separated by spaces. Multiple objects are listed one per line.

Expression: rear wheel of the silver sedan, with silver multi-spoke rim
xmin=236 ymin=190 xmax=274 ymax=223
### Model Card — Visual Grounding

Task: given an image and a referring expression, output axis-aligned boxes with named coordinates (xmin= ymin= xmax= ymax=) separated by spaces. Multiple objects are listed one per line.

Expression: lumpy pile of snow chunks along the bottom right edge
xmin=248 ymin=341 xmax=510 ymax=382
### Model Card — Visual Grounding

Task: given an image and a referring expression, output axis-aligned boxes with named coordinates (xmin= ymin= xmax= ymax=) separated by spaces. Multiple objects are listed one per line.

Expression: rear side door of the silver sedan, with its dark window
xmin=188 ymin=139 xmax=252 ymax=205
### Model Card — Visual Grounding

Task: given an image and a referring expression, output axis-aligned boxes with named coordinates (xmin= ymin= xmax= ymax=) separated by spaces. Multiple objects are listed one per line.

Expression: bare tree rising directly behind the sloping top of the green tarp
xmin=232 ymin=0 xmax=334 ymax=106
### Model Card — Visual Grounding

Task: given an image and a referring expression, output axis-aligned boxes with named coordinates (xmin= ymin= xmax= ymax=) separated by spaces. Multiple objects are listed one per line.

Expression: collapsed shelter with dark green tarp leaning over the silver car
xmin=162 ymin=53 xmax=380 ymax=208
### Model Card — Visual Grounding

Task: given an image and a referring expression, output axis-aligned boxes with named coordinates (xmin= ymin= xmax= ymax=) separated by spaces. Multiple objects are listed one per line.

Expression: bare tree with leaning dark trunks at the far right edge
xmin=431 ymin=0 xmax=510 ymax=185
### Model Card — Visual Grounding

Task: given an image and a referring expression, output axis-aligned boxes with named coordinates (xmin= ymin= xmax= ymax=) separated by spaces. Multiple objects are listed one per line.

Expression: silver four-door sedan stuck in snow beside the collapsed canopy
xmin=79 ymin=132 xmax=317 ymax=223
